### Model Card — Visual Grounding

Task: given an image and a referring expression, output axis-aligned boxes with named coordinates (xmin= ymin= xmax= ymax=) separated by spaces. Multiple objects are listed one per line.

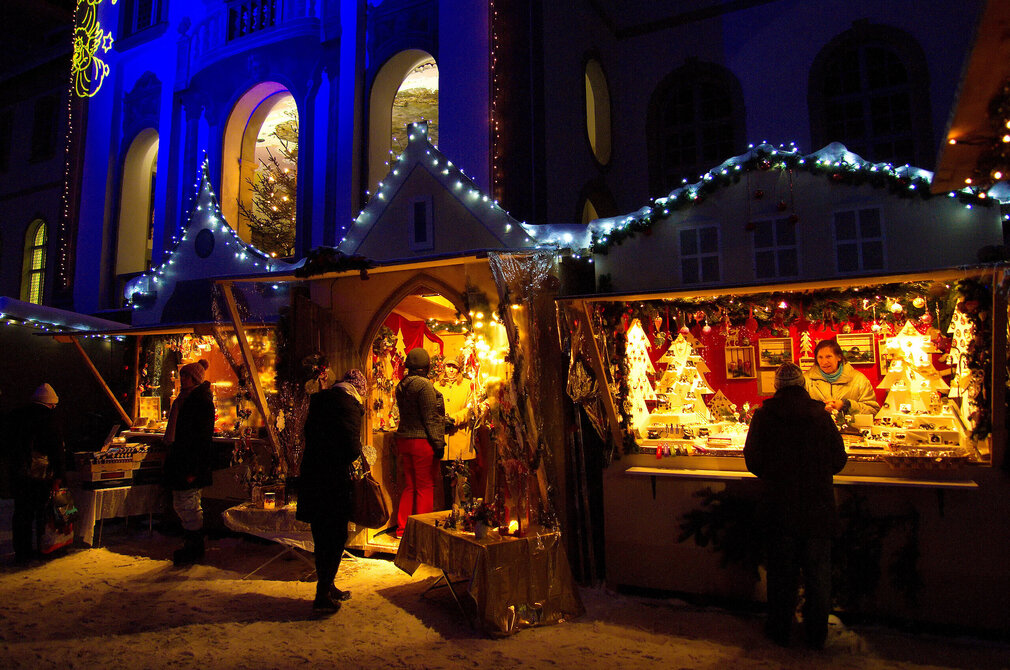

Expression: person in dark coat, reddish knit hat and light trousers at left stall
xmin=165 ymin=359 xmax=214 ymax=565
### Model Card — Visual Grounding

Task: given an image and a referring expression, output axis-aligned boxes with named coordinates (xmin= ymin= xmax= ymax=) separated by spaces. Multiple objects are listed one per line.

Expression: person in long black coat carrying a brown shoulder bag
xmin=295 ymin=370 xmax=368 ymax=611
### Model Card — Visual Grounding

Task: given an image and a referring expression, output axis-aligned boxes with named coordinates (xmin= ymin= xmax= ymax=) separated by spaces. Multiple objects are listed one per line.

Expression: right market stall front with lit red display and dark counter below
xmin=560 ymin=266 xmax=1010 ymax=629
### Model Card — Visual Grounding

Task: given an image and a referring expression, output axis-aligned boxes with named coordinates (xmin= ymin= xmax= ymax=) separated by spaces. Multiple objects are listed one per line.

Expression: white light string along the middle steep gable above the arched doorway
xmin=337 ymin=121 xmax=535 ymax=253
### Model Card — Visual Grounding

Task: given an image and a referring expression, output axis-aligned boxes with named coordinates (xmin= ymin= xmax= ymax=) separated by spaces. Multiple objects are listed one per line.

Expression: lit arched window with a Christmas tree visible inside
xmin=221 ymin=82 xmax=298 ymax=257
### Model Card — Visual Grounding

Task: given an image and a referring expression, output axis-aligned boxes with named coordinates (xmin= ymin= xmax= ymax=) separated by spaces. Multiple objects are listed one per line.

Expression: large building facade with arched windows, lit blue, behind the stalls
xmin=0 ymin=0 xmax=985 ymax=313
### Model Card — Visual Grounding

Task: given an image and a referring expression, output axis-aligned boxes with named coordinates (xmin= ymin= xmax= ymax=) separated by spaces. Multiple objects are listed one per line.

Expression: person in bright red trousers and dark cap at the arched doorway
xmin=396 ymin=348 xmax=445 ymax=538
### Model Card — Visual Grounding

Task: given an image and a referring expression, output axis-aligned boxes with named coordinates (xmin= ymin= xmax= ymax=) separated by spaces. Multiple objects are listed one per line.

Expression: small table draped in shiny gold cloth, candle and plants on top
xmin=395 ymin=511 xmax=585 ymax=635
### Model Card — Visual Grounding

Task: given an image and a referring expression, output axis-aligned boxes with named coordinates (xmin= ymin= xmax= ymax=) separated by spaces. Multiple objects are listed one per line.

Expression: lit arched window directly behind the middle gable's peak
xmin=368 ymin=49 xmax=438 ymax=193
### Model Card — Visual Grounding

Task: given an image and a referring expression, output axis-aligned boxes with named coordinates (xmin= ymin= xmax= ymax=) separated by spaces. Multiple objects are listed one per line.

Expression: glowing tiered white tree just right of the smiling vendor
xmin=877 ymin=321 xmax=949 ymax=420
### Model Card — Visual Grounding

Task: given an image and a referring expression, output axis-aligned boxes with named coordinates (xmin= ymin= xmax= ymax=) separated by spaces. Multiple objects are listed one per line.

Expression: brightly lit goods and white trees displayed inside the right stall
xmin=596 ymin=278 xmax=992 ymax=470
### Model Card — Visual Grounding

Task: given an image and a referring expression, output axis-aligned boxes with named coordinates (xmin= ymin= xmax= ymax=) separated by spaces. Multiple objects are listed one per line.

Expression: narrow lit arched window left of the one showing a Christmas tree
xmin=116 ymin=128 xmax=158 ymax=275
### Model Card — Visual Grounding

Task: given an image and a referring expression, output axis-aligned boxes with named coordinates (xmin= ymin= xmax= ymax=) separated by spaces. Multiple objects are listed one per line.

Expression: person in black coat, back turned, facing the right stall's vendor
xmin=743 ymin=363 xmax=848 ymax=649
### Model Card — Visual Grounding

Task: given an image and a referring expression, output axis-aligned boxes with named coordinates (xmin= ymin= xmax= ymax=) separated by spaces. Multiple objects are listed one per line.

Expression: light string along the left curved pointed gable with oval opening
xmin=126 ymin=158 xmax=286 ymax=309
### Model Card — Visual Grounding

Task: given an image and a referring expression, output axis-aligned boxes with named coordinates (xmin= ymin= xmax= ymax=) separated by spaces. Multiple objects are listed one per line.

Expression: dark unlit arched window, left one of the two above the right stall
xmin=648 ymin=62 xmax=745 ymax=195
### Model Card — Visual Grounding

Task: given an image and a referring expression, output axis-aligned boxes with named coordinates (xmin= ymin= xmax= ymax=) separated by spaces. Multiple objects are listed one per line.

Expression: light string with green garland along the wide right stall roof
xmin=589 ymin=142 xmax=995 ymax=254
